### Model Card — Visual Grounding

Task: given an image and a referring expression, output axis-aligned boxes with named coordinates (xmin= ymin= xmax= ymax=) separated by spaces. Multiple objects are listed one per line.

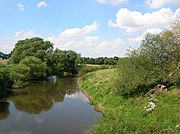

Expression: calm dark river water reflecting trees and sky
xmin=0 ymin=78 xmax=100 ymax=134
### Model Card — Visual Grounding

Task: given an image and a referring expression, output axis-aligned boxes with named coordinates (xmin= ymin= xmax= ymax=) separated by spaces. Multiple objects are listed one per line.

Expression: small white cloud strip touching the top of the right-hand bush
xmin=128 ymin=28 xmax=163 ymax=44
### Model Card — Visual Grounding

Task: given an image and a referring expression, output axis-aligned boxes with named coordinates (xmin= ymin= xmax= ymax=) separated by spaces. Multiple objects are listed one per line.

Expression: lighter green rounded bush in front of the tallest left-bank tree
xmin=8 ymin=56 xmax=47 ymax=88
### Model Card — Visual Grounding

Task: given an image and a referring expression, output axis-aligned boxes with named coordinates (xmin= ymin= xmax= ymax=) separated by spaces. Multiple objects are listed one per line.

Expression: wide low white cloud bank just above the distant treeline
xmin=47 ymin=21 xmax=124 ymax=57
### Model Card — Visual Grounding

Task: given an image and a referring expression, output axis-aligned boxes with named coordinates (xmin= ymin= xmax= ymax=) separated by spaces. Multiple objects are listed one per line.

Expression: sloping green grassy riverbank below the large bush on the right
xmin=80 ymin=69 xmax=180 ymax=134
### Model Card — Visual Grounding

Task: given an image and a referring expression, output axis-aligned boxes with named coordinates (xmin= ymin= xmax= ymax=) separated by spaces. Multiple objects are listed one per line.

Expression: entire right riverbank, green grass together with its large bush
xmin=80 ymin=22 xmax=180 ymax=134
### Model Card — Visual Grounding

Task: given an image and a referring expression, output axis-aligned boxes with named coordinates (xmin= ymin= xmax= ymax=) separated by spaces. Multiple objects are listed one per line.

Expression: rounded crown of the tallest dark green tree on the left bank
xmin=10 ymin=37 xmax=53 ymax=64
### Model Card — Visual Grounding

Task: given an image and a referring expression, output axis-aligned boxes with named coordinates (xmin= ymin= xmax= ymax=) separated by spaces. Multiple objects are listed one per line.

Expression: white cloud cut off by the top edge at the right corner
xmin=146 ymin=0 xmax=180 ymax=8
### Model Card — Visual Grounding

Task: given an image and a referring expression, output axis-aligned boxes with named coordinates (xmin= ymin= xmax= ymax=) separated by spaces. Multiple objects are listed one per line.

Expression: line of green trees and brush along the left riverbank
xmin=0 ymin=37 xmax=118 ymax=98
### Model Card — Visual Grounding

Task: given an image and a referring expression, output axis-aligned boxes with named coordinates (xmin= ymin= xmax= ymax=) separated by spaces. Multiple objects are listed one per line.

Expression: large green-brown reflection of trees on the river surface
xmin=11 ymin=79 xmax=79 ymax=114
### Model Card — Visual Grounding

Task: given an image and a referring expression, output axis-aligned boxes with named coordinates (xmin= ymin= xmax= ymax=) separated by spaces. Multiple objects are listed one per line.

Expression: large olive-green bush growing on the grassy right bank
xmin=116 ymin=22 xmax=180 ymax=97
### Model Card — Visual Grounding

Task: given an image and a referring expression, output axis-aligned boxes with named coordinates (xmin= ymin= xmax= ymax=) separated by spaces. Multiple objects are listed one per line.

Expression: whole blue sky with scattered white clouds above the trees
xmin=0 ymin=0 xmax=180 ymax=57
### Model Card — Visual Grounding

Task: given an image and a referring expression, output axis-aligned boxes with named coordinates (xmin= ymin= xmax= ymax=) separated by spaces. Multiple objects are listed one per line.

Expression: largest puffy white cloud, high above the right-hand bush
xmin=108 ymin=8 xmax=180 ymax=33
